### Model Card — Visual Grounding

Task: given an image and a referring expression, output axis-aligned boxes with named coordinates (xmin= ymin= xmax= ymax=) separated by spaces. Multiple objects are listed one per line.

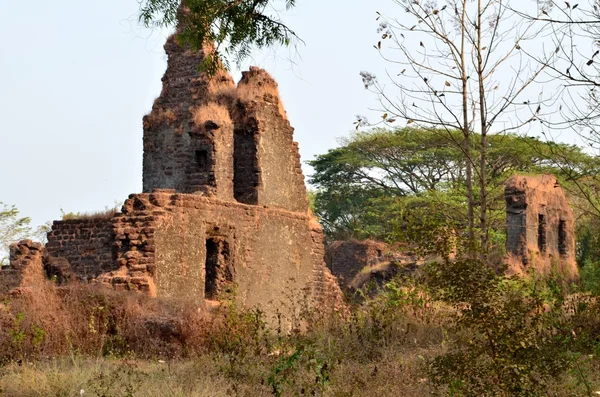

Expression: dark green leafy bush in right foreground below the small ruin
xmin=427 ymin=260 xmax=572 ymax=396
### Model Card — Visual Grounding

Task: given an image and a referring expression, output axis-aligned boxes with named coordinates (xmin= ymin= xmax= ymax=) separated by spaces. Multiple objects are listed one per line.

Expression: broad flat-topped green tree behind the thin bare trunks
xmin=309 ymin=128 xmax=600 ymax=253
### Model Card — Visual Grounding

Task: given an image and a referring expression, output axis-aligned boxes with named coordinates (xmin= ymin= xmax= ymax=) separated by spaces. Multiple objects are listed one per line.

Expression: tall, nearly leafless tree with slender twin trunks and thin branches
xmin=358 ymin=0 xmax=560 ymax=256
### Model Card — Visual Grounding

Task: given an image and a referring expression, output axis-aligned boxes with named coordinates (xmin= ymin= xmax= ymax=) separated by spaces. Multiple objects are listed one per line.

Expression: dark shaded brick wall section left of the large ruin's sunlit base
xmin=46 ymin=217 xmax=116 ymax=281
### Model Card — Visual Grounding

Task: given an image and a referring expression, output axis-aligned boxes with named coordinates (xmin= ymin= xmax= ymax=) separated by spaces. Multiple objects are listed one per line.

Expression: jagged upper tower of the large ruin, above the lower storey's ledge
xmin=143 ymin=30 xmax=308 ymax=212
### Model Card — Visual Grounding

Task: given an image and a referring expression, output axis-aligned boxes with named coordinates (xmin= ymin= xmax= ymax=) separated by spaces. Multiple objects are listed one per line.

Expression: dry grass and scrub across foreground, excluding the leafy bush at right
xmin=0 ymin=276 xmax=600 ymax=397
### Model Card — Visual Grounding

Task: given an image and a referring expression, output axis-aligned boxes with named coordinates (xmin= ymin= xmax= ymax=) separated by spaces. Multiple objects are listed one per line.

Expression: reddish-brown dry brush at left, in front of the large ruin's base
xmin=0 ymin=281 xmax=211 ymax=362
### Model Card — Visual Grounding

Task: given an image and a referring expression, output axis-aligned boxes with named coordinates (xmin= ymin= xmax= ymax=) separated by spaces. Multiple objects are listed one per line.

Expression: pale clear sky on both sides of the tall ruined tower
xmin=0 ymin=0 xmax=584 ymax=229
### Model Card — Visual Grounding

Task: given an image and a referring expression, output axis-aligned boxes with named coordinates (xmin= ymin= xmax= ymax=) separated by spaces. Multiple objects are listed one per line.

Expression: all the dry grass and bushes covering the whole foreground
xmin=0 ymin=260 xmax=600 ymax=396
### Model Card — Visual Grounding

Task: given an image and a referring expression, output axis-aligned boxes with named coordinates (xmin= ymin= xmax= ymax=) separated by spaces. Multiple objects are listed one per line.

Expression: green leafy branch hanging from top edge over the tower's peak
xmin=139 ymin=0 xmax=300 ymax=72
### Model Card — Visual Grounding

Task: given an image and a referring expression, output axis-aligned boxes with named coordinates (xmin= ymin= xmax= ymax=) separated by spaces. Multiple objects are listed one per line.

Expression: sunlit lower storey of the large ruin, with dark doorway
xmin=81 ymin=190 xmax=341 ymax=317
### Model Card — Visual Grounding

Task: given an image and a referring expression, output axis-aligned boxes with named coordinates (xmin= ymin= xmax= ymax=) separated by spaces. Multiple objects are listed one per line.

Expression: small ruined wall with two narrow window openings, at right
xmin=504 ymin=175 xmax=578 ymax=279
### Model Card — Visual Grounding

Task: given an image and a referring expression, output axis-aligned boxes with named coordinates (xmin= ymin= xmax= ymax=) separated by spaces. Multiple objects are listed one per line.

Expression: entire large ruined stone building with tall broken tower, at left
xmin=0 ymin=31 xmax=340 ymax=314
